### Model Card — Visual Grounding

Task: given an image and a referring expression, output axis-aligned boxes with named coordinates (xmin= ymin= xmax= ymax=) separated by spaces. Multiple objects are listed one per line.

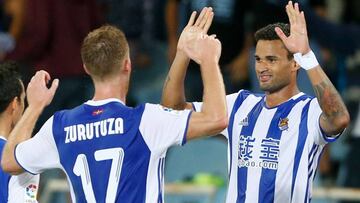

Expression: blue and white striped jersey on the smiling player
xmin=193 ymin=90 xmax=337 ymax=203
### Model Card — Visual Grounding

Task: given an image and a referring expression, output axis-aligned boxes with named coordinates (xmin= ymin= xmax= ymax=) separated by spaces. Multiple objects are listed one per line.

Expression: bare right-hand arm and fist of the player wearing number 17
xmin=184 ymin=34 xmax=228 ymax=140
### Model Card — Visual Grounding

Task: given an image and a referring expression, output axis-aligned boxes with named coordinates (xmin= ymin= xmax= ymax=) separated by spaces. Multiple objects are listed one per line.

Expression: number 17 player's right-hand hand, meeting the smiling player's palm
xmin=184 ymin=34 xmax=221 ymax=65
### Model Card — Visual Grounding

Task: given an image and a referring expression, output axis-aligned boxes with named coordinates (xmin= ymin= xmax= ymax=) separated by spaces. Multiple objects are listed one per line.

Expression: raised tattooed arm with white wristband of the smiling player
xmin=276 ymin=1 xmax=350 ymax=135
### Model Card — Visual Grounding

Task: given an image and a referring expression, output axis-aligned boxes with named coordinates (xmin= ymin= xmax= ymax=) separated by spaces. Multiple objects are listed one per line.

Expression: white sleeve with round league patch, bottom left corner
xmin=8 ymin=172 xmax=40 ymax=203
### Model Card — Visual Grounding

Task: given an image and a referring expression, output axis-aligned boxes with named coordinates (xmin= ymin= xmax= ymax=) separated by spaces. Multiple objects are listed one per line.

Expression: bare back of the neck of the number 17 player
xmin=92 ymin=77 xmax=128 ymax=104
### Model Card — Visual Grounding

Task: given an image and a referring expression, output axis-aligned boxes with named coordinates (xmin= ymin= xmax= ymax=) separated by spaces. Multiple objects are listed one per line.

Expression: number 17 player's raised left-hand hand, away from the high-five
xmin=26 ymin=70 xmax=59 ymax=108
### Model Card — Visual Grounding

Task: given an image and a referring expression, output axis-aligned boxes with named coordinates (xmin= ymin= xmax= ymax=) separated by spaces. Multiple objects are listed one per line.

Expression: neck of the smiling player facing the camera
xmin=265 ymin=85 xmax=300 ymax=108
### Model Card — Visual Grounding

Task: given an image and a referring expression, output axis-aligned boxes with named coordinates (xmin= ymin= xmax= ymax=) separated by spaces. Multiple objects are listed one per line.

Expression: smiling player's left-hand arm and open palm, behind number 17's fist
xmin=161 ymin=7 xmax=214 ymax=110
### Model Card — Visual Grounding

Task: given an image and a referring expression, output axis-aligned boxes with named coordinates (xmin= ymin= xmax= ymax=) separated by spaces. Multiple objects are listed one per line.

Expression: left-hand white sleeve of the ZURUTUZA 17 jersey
xmin=15 ymin=117 xmax=60 ymax=174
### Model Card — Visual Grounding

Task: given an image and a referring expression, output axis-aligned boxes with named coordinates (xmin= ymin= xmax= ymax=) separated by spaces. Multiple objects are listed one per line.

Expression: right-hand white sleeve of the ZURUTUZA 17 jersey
xmin=139 ymin=104 xmax=191 ymax=152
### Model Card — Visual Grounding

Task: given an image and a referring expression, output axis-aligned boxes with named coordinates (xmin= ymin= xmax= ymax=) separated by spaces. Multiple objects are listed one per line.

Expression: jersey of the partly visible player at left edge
xmin=0 ymin=136 xmax=40 ymax=203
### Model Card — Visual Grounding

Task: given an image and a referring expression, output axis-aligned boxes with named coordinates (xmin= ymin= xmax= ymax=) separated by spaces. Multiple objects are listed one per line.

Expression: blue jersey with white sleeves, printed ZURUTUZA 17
xmin=15 ymin=99 xmax=190 ymax=203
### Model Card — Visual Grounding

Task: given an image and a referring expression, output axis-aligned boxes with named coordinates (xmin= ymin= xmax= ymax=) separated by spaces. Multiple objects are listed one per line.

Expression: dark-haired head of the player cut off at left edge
xmin=0 ymin=62 xmax=25 ymax=128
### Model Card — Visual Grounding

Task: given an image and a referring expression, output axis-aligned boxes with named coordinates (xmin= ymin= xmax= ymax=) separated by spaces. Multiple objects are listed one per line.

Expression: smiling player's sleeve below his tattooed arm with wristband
xmin=308 ymin=98 xmax=341 ymax=145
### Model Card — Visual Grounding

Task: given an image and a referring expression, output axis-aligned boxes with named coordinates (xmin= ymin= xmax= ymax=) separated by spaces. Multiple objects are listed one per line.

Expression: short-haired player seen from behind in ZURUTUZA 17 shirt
xmin=2 ymin=11 xmax=228 ymax=203
